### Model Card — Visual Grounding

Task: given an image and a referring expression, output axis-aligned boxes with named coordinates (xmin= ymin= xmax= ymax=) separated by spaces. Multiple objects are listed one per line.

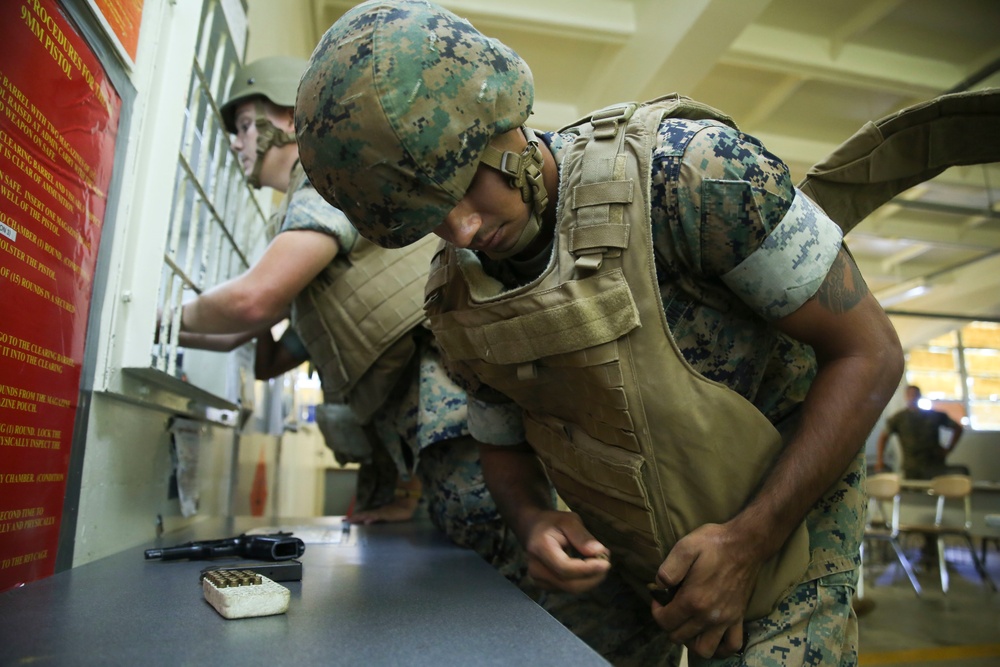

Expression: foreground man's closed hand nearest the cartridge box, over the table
xmin=525 ymin=510 xmax=611 ymax=593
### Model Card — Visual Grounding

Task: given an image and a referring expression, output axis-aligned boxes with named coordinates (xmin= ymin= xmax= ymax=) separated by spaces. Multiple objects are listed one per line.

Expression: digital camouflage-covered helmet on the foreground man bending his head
xmin=295 ymin=0 xmax=534 ymax=248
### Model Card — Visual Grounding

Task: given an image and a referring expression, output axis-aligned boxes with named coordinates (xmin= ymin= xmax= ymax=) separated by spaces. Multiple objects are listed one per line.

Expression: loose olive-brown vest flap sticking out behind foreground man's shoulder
xmin=798 ymin=89 xmax=1000 ymax=232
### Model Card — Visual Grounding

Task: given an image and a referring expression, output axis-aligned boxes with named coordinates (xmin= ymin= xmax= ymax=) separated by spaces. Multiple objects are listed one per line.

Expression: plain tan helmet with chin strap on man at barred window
xmin=219 ymin=56 xmax=307 ymax=188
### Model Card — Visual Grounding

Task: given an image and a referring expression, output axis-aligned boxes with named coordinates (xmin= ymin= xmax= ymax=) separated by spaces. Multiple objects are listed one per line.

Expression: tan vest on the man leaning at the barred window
xmin=289 ymin=167 xmax=437 ymax=424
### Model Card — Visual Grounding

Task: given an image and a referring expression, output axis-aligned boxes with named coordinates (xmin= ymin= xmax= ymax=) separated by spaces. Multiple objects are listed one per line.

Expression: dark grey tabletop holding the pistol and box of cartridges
xmin=0 ymin=517 xmax=608 ymax=667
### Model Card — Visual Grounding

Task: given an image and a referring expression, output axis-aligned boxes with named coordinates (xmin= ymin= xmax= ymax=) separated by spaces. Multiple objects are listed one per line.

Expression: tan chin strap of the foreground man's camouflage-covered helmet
xmin=481 ymin=126 xmax=549 ymax=259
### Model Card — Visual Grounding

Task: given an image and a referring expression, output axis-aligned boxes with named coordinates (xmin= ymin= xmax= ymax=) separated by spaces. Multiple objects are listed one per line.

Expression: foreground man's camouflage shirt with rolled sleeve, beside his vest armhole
xmin=650 ymin=119 xmax=842 ymax=422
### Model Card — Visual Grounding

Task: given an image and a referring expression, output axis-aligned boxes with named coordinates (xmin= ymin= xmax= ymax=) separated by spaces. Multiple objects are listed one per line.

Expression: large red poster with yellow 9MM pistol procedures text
xmin=0 ymin=0 xmax=121 ymax=590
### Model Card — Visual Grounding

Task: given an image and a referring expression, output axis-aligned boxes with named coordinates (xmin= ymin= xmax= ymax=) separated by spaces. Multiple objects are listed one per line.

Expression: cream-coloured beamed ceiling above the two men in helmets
xmin=247 ymin=0 xmax=1000 ymax=347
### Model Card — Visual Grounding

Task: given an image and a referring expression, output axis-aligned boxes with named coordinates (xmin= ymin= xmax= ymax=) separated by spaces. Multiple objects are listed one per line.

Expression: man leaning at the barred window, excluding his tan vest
xmin=181 ymin=57 xmax=525 ymax=580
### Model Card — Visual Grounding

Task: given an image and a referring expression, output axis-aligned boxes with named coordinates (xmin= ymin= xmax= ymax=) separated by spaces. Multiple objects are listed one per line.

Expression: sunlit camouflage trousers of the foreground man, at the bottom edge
xmin=688 ymin=571 xmax=858 ymax=667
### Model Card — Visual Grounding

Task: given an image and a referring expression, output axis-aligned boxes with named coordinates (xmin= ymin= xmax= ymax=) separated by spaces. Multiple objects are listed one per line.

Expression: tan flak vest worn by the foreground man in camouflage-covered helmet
xmin=427 ymin=96 xmax=809 ymax=618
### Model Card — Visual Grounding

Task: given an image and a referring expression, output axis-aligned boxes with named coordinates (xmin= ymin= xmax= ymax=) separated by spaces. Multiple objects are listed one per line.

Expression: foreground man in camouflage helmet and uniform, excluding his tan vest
xmin=296 ymin=1 xmax=902 ymax=665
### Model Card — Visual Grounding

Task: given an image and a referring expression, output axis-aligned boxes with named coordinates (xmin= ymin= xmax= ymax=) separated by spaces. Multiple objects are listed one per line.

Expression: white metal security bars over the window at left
xmin=153 ymin=0 xmax=265 ymax=377
